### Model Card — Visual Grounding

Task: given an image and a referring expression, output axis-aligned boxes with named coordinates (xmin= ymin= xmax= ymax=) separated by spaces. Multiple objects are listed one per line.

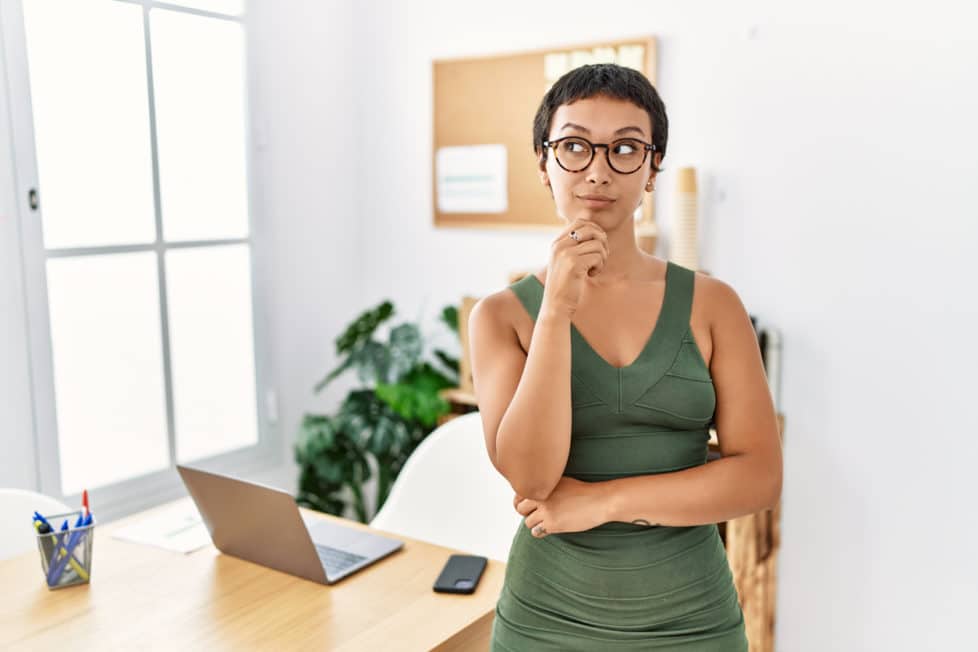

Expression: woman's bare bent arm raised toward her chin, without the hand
xmin=469 ymin=294 xmax=571 ymax=500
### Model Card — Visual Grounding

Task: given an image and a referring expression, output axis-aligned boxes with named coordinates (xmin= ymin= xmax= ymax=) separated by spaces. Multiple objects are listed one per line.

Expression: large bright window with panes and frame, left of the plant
xmin=0 ymin=0 xmax=278 ymax=517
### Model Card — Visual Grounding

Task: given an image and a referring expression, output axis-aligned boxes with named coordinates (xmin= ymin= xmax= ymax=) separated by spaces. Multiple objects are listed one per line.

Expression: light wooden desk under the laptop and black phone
xmin=0 ymin=499 xmax=506 ymax=652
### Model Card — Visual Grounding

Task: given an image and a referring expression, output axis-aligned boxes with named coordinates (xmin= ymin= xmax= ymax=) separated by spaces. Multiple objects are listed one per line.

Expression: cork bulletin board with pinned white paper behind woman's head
xmin=432 ymin=37 xmax=656 ymax=229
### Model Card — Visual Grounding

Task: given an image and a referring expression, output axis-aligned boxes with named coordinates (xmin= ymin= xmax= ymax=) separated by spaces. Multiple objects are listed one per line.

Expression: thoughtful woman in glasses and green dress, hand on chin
xmin=469 ymin=64 xmax=781 ymax=652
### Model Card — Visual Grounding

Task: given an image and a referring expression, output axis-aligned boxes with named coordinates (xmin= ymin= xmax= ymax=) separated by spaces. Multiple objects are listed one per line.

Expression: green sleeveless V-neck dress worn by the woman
xmin=490 ymin=261 xmax=747 ymax=652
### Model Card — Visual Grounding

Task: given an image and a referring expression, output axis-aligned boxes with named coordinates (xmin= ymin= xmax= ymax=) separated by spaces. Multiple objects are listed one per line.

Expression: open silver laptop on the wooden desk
xmin=177 ymin=464 xmax=404 ymax=584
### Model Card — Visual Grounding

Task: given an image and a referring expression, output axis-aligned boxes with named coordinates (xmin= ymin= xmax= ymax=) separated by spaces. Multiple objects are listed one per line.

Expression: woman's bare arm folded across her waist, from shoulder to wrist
xmin=596 ymin=276 xmax=782 ymax=526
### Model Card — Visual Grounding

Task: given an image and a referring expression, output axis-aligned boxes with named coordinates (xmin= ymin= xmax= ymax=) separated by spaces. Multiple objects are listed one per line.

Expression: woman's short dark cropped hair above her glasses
xmin=533 ymin=63 xmax=669 ymax=172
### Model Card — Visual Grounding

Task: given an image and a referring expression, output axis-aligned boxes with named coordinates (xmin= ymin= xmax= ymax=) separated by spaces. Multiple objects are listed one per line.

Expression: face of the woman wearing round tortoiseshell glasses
xmin=540 ymin=96 xmax=660 ymax=230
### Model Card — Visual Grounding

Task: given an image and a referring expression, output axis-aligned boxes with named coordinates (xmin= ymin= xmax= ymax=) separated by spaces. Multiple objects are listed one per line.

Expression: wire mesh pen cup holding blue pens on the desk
xmin=37 ymin=511 xmax=95 ymax=589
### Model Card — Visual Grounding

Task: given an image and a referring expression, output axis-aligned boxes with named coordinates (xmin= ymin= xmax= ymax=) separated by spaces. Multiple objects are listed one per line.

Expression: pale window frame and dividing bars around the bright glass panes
xmin=0 ymin=0 xmax=284 ymax=520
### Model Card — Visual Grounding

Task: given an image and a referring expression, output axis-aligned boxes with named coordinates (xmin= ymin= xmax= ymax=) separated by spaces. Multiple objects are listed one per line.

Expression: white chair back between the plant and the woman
xmin=370 ymin=412 xmax=523 ymax=561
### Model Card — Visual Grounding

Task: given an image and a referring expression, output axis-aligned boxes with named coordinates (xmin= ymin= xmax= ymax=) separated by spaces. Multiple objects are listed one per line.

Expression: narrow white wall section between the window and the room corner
xmin=248 ymin=1 xmax=362 ymax=491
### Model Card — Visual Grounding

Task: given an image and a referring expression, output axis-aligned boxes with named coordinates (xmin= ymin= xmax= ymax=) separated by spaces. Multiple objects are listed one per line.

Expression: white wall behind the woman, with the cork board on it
xmin=346 ymin=0 xmax=978 ymax=652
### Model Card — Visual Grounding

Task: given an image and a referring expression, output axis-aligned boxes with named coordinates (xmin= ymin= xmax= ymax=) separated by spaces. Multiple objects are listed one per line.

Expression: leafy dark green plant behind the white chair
xmin=295 ymin=301 xmax=459 ymax=523
